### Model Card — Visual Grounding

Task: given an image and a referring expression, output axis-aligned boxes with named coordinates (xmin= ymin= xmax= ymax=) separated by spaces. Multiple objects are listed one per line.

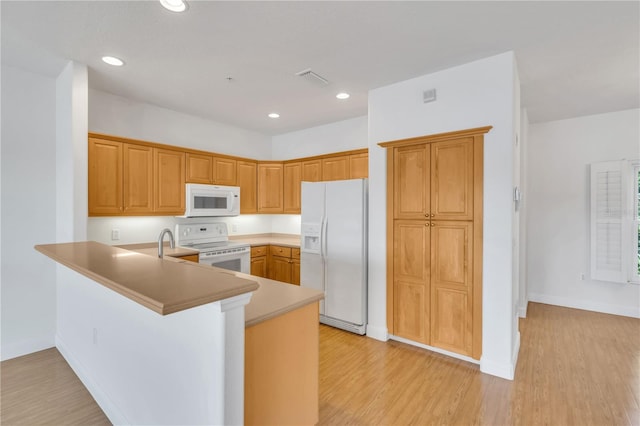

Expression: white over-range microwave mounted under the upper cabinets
xmin=184 ymin=183 xmax=240 ymax=217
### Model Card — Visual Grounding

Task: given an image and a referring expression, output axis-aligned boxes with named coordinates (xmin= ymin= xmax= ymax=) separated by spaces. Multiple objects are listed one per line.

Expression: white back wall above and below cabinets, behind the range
xmin=87 ymin=90 xmax=272 ymax=244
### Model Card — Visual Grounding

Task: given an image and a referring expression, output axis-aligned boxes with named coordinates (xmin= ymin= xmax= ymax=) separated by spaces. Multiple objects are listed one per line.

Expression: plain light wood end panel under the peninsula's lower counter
xmin=244 ymin=302 xmax=320 ymax=425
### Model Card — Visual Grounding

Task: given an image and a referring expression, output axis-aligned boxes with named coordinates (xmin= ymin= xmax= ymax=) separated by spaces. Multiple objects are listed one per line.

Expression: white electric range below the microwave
xmin=176 ymin=223 xmax=251 ymax=274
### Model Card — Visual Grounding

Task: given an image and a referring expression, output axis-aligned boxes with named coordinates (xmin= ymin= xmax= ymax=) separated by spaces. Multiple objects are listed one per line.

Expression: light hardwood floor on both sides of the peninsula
xmin=0 ymin=303 xmax=640 ymax=425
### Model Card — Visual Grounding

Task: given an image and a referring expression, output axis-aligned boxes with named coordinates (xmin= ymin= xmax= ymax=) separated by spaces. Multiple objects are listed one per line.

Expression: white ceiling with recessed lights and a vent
xmin=0 ymin=0 xmax=640 ymax=135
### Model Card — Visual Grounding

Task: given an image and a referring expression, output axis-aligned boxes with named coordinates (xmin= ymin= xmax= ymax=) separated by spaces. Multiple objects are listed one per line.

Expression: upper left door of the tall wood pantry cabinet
xmin=393 ymin=145 xmax=431 ymax=219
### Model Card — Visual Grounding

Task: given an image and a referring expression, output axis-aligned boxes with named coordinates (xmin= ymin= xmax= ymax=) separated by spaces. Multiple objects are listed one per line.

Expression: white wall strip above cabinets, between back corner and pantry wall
xmin=272 ymin=116 xmax=367 ymax=160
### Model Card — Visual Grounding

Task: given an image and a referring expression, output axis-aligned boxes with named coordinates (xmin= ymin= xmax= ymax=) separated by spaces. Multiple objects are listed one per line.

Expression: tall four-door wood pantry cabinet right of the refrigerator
xmin=380 ymin=127 xmax=491 ymax=359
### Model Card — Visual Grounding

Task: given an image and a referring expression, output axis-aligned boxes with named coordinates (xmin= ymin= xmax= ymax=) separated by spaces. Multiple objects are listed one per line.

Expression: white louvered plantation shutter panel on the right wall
xmin=591 ymin=161 xmax=628 ymax=282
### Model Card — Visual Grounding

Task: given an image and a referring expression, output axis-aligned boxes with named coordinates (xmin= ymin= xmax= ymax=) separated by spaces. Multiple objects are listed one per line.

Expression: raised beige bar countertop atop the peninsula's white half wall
xmin=35 ymin=241 xmax=258 ymax=315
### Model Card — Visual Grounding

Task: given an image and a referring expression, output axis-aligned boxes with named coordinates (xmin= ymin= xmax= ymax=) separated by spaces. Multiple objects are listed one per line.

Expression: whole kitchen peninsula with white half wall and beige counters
xmin=36 ymin=242 xmax=323 ymax=424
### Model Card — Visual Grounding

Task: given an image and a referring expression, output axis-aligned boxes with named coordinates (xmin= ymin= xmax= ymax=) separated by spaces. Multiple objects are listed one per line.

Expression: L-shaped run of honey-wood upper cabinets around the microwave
xmin=88 ymin=133 xmax=370 ymax=218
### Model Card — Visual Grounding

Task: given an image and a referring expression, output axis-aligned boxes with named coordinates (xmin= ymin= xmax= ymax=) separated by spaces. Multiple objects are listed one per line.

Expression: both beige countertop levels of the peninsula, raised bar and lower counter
xmin=36 ymin=241 xmax=324 ymax=327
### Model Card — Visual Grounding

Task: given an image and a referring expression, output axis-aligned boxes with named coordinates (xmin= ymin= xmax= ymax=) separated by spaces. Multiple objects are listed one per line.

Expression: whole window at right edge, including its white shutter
xmin=591 ymin=161 xmax=640 ymax=283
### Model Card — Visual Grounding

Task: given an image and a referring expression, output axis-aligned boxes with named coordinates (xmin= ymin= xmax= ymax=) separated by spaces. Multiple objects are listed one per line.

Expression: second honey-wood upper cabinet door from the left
xmin=123 ymin=143 xmax=154 ymax=215
